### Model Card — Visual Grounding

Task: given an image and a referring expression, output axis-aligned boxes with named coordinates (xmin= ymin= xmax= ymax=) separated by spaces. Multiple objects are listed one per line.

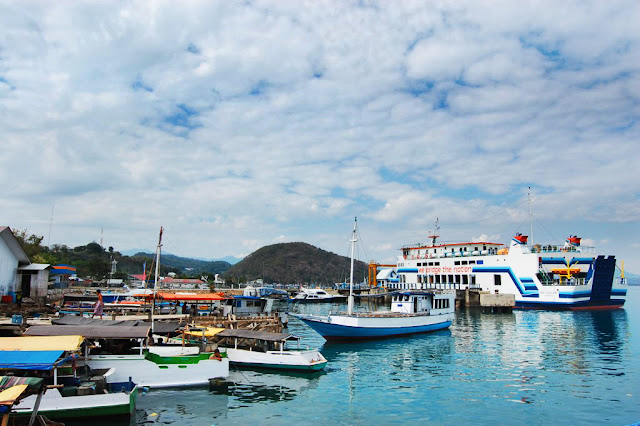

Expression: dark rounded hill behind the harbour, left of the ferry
xmin=224 ymin=243 xmax=367 ymax=285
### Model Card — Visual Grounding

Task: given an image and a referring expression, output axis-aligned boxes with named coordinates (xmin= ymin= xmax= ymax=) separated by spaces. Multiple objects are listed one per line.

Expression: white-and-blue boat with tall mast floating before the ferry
xmin=290 ymin=220 xmax=455 ymax=340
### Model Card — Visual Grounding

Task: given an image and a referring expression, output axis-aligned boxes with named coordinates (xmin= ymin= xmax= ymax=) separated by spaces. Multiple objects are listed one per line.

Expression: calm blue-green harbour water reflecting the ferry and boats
xmin=133 ymin=287 xmax=640 ymax=425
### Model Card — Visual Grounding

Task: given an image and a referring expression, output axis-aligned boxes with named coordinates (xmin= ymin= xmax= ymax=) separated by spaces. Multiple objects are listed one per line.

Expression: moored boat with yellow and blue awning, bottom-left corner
xmin=0 ymin=336 xmax=138 ymax=419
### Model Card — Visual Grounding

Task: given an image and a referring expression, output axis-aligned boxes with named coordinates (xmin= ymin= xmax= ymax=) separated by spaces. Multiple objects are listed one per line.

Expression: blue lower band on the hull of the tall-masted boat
xmin=300 ymin=318 xmax=451 ymax=340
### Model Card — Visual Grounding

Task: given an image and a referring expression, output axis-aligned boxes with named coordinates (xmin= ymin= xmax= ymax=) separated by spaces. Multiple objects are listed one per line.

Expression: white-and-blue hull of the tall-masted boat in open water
xmin=298 ymin=315 xmax=453 ymax=340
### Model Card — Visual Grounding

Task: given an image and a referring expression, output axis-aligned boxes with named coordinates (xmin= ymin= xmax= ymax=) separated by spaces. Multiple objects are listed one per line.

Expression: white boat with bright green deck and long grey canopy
xmin=25 ymin=325 xmax=229 ymax=388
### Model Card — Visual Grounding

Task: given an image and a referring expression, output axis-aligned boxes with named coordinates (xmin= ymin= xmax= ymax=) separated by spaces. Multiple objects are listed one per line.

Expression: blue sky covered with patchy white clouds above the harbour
xmin=0 ymin=0 xmax=640 ymax=274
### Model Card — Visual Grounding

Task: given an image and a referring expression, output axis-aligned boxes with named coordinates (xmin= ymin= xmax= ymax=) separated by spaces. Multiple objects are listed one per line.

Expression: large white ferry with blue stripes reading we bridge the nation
xmin=389 ymin=222 xmax=627 ymax=309
